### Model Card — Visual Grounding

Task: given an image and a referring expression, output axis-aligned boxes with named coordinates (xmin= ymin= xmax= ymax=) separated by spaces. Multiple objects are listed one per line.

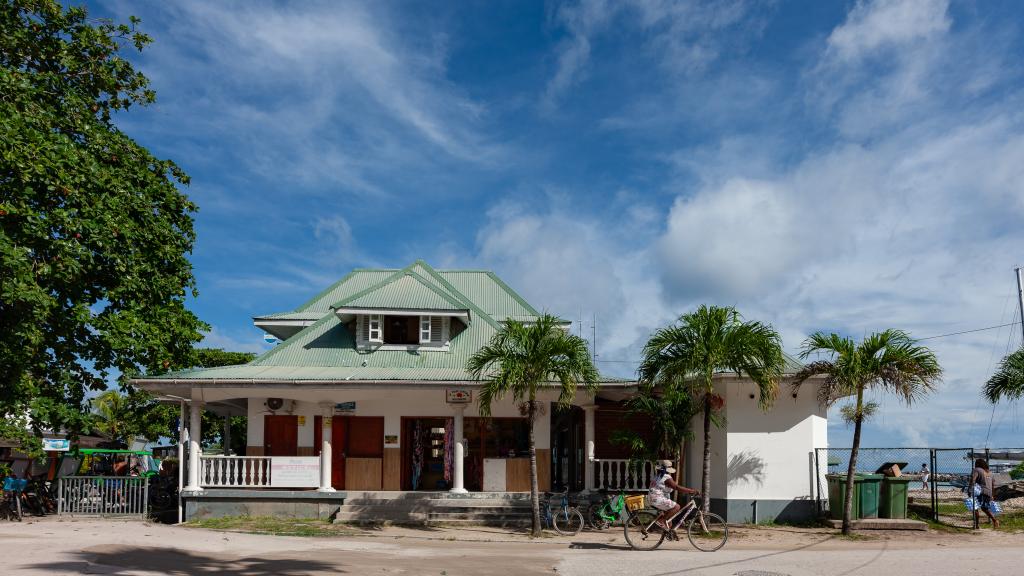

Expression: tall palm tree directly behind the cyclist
xmin=639 ymin=305 xmax=785 ymax=511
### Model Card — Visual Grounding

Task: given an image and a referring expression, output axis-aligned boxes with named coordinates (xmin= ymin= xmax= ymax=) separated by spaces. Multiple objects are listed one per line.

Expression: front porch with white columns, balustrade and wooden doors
xmin=163 ymin=384 xmax=647 ymax=521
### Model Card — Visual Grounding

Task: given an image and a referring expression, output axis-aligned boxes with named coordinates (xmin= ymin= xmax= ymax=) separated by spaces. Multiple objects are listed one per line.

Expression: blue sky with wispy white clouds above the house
xmin=91 ymin=0 xmax=1024 ymax=447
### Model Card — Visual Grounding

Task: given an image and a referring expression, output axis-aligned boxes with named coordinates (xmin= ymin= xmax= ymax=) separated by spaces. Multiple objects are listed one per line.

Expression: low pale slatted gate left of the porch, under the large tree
xmin=57 ymin=476 xmax=150 ymax=519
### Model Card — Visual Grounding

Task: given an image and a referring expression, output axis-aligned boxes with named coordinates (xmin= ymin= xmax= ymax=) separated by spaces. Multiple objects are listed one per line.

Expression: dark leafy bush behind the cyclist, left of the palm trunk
xmin=611 ymin=386 xmax=700 ymax=469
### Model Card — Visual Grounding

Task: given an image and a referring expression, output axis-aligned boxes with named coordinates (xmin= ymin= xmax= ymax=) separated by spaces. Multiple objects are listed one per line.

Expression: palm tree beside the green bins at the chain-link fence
xmin=793 ymin=330 xmax=942 ymax=534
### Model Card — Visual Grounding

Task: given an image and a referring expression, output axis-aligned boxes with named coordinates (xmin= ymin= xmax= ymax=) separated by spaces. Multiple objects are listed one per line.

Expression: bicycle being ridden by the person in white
xmin=624 ymin=495 xmax=729 ymax=552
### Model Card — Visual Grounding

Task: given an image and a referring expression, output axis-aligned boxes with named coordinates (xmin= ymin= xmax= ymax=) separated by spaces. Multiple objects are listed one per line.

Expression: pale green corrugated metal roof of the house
xmin=145 ymin=260 xmax=630 ymax=383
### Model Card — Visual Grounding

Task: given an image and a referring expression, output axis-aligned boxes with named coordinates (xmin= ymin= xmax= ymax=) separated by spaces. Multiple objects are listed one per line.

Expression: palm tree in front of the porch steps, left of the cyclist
xmin=466 ymin=314 xmax=599 ymax=536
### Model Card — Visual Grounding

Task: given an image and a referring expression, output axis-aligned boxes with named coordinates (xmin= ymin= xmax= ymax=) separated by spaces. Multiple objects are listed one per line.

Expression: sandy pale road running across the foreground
xmin=0 ymin=519 xmax=1024 ymax=576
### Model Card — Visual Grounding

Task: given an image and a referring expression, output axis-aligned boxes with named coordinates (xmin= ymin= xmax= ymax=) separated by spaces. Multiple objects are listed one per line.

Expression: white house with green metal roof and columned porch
xmin=134 ymin=260 xmax=826 ymax=522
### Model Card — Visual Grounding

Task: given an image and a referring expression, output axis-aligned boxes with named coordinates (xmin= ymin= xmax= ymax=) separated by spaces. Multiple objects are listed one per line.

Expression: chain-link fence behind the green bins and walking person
xmin=813 ymin=448 xmax=1024 ymax=528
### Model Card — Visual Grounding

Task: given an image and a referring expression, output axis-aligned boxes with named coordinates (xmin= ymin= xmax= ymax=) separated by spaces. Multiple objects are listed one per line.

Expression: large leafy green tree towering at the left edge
xmin=0 ymin=0 xmax=207 ymax=449
